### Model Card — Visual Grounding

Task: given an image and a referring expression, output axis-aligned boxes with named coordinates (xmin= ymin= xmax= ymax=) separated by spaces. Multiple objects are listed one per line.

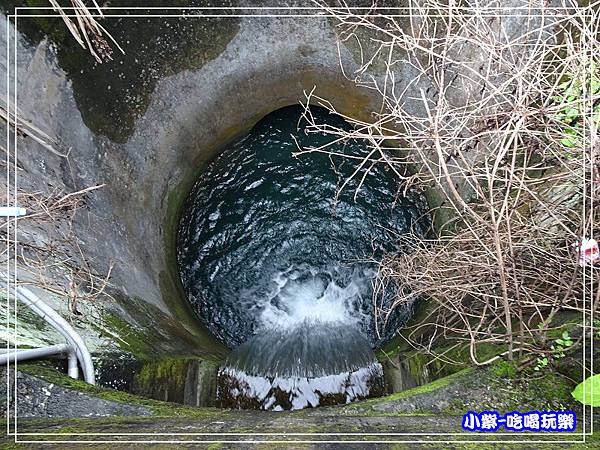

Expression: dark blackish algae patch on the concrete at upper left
xmin=7 ymin=0 xmax=239 ymax=142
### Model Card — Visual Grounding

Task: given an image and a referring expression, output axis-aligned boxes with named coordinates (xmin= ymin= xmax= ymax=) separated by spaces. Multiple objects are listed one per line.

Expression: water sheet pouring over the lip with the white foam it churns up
xmin=218 ymin=267 xmax=383 ymax=411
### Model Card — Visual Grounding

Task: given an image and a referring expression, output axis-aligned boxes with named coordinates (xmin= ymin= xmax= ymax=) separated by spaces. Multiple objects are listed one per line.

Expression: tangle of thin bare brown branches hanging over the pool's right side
xmin=300 ymin=0 xmax=600 ymax=364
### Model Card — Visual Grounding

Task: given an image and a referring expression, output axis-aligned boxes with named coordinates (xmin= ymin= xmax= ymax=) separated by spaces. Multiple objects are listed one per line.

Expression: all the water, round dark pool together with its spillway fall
xmin=178 ymin=107 xmax=422 ymax=409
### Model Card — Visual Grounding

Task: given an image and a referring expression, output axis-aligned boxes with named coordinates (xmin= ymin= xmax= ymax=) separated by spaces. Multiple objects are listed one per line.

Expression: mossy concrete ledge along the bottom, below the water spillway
xmin=5 ymin=367 xmax=597 ymax=449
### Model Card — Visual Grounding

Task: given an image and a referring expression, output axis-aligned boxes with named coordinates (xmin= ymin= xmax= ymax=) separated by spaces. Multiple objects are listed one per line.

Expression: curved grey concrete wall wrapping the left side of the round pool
xmin=0 ymin=2 xmax=394 ymax=360
